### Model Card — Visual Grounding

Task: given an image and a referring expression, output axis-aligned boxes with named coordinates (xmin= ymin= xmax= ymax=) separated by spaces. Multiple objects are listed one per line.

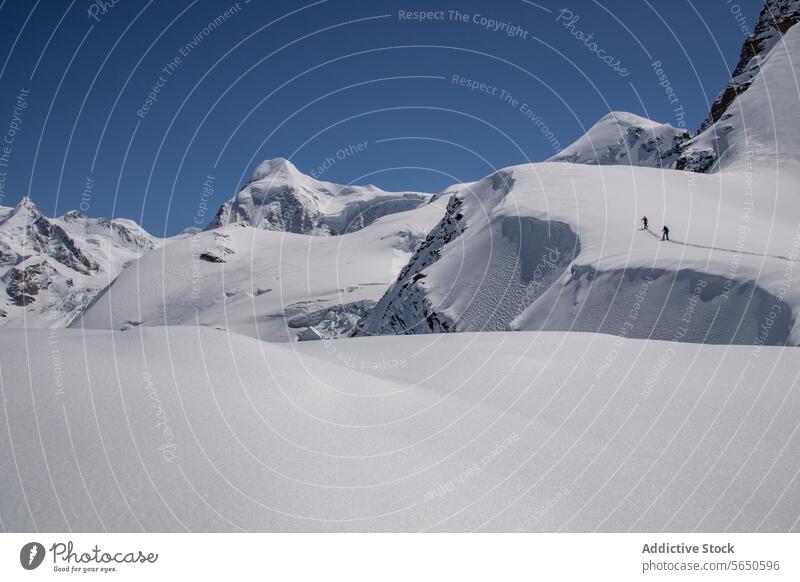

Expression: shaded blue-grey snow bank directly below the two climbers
xmin=512 ymin=267 xmax=795 ymax=346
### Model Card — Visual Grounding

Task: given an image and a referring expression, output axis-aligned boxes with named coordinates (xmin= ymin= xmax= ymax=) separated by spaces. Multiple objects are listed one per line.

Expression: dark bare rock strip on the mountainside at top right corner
xmin=700 ymin=0 xmax=800 ymax=131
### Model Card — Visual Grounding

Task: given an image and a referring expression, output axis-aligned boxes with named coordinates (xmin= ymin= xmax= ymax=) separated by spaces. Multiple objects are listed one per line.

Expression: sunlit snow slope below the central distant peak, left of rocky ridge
xmin=74 ymin=199 xmax=446 ymax=341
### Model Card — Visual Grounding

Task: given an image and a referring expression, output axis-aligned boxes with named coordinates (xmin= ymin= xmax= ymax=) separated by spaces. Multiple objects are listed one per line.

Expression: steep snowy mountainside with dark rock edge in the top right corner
xmin=677 ymin=0 xmax=800 ymax=172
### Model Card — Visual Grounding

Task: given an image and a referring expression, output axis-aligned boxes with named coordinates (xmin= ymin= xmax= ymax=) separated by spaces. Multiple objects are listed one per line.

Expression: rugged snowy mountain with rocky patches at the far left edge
xmin=0 ymin=197 xmax=160 ymax=328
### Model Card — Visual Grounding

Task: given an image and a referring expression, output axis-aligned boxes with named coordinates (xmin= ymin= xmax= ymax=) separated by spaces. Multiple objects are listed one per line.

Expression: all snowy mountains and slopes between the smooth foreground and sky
xmin=6 ymin=0 xmax=800 ymax=344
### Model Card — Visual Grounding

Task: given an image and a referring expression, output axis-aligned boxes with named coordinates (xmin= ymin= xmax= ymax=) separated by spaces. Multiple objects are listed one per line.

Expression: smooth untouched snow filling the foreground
xmin=0 ymin=327 xmax=800 ymax=532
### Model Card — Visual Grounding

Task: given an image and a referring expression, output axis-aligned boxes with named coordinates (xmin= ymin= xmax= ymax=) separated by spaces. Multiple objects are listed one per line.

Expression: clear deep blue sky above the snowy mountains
xmin=0 ymin=0 xmax=761 ymax=235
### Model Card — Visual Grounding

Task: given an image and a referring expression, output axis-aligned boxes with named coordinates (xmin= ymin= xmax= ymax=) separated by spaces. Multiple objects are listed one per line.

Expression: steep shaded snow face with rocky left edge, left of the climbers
xmin=356 ymin=185 xmax=580 ymax=335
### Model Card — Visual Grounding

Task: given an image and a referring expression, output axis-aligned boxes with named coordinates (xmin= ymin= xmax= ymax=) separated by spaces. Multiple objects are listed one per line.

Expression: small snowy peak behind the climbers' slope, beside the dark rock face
xmin=548 ymin=111 xmax=691 ymax=168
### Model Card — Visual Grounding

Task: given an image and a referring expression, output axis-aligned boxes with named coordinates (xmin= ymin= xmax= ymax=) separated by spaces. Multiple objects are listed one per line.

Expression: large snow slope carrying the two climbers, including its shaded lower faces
xmin=357 ymin=163 xmax=800 ymax=344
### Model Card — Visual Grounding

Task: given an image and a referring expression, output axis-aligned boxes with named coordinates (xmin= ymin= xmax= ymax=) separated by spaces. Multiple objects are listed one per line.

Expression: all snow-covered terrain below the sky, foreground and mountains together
xmin=0 ymin=0 xmax=800 ymax=532
